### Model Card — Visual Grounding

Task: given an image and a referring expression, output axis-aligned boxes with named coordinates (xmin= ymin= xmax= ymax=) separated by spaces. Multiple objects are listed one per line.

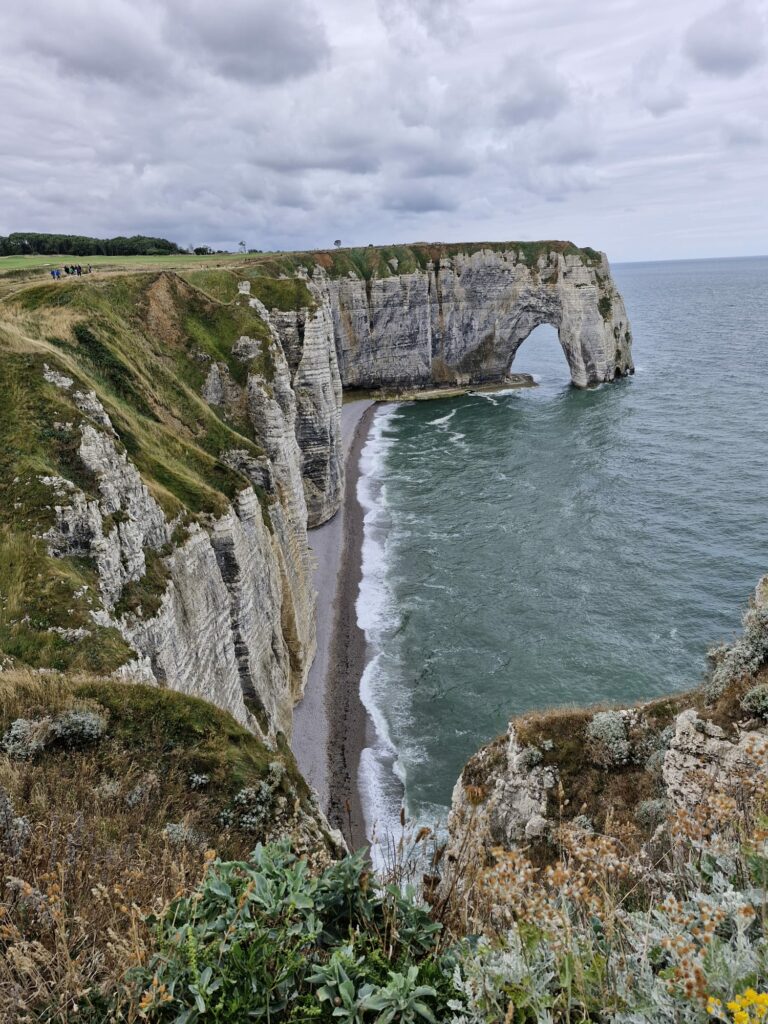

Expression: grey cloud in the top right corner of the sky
xmin=685 ymin=0 xmax=765 ymax=78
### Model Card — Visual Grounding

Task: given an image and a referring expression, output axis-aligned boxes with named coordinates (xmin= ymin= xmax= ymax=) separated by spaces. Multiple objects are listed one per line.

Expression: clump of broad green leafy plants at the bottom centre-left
xmin=127 ymin=844 xmax=454 ymax=1024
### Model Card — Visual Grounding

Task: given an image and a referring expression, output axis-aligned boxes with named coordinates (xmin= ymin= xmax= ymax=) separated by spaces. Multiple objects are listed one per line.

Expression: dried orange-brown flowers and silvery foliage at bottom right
xmin=438 ymin=736 xmax=768 ymax=1024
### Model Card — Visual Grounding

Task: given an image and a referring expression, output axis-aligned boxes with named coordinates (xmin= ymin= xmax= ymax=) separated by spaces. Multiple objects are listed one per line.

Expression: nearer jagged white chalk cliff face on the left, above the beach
xmin=38 ymin=368 xmax=314 ymax=736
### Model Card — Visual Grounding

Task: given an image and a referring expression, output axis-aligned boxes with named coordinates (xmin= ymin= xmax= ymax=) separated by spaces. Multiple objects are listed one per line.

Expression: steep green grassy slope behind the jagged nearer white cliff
xmin=10 ymin=274 xmax=269 ymax=514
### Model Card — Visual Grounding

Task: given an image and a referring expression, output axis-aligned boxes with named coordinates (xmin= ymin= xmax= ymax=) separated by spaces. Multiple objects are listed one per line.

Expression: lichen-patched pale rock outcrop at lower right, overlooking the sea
xmin=447 ymin=578 xmax=768 ymax=860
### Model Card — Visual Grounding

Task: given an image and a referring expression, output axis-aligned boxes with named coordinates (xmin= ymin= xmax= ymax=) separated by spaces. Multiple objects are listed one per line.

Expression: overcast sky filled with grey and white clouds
xmin=0 ymin=0 xmax=768 ymax=260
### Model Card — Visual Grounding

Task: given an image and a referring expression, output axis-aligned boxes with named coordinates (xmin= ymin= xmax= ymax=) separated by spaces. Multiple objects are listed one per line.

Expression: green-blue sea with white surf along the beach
xmin=357 ymin=258 xmax=768 ymax=830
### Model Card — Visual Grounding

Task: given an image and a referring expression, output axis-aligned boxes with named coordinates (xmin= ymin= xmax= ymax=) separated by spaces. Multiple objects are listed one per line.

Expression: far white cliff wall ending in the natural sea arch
xmin=314 ymin=250 xmax=634 ymax=388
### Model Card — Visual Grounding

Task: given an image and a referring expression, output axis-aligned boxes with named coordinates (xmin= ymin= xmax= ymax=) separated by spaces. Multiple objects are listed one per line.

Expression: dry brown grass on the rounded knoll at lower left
xmin=0 ymin=673 xmax=327 ymax=1024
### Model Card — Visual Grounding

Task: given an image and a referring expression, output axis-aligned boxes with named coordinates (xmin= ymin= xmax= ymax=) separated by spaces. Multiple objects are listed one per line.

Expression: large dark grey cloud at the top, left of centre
xmin=166 ymin=0 xmax=331 ymax=84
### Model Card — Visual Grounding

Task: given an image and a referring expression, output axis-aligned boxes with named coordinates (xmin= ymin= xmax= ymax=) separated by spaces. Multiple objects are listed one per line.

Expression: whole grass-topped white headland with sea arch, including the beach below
xmin=0 ymin=242 xmax=633 ymax=842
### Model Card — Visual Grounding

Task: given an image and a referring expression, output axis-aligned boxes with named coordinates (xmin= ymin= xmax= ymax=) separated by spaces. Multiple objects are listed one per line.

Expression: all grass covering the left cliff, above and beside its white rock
xmin=0 ymin=271 xmax=280 ymax=672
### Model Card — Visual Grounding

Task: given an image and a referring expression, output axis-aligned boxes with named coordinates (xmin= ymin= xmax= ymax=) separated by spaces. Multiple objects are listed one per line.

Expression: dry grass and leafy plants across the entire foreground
xmin=0 ymin=602 xmax=768 ymax=1024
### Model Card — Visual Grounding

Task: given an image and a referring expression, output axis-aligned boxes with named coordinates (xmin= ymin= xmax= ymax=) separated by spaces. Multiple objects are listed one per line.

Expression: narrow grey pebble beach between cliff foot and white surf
xmin=291 ymin=398 xmax=376 ymax=849
